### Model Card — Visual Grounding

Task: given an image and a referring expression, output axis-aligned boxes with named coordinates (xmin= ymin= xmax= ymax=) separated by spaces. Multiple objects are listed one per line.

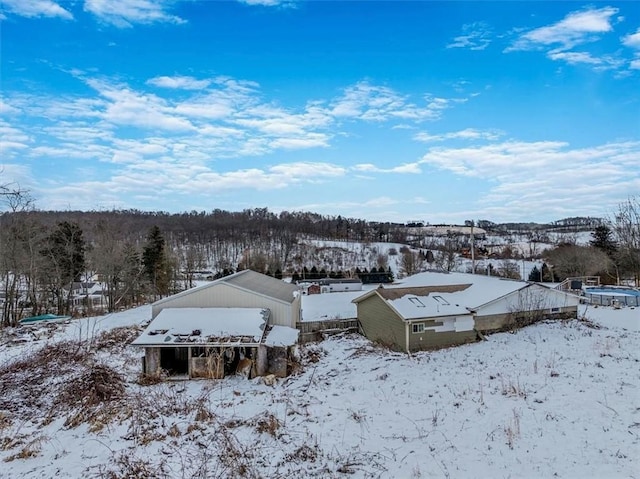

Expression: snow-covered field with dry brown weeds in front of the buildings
xmin=0 ymin=304 xmax=640 ymax=478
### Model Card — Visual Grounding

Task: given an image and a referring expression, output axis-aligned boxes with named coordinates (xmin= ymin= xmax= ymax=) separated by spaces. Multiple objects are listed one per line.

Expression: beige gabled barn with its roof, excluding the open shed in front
xmin=151 ymin=269 xmax=301 ymax=328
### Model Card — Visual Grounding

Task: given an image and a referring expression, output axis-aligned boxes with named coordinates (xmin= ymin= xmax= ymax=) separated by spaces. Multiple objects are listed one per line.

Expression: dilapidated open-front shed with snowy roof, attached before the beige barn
xmin=132 ymin=308 xmax=298 ymax=379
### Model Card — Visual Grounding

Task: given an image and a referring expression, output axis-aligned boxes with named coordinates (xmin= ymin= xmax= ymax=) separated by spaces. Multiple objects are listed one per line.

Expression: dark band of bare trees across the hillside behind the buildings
xmin=0 ymin=180 xmax=640 ymax=325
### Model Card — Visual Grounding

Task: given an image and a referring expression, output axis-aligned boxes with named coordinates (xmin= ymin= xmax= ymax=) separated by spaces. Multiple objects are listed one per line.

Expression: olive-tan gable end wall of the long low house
xmin=357 ymin=295 xmax=406 ymax=351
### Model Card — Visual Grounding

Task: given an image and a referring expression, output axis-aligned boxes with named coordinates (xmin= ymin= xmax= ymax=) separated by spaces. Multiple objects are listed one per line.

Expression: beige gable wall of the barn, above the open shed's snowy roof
xmin=152 ymin=283 xmax=301 ymax=328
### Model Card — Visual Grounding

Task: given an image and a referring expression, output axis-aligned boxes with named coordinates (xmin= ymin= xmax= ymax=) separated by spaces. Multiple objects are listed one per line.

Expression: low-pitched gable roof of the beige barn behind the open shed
xmin=153 ymin=269 xmax=299 ymax=305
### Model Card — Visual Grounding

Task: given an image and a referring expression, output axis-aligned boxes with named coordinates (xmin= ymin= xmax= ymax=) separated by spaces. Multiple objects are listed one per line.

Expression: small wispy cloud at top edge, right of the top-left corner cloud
xmin=84 ymin=0 xmax=186 ymax=28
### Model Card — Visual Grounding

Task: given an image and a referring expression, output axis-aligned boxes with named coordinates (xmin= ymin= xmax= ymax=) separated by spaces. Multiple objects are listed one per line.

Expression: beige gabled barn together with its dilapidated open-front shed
xmin=132 ymin=270 xmax=300 ymax=378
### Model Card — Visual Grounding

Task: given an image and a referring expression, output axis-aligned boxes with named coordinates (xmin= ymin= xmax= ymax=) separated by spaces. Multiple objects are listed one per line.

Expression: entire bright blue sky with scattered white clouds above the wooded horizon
xmin=0 ymin=0 xmax=640 ymax=223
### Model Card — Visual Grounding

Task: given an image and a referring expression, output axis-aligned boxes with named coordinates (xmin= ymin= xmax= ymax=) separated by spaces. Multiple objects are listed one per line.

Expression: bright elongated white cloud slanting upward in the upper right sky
xmin=511 ymin=7 xmax=618 ymax=50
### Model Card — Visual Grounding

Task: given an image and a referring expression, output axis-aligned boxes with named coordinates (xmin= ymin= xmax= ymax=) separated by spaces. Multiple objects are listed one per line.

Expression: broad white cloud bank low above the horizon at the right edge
xmin=420 ymin=141 xmax=640 ymax=218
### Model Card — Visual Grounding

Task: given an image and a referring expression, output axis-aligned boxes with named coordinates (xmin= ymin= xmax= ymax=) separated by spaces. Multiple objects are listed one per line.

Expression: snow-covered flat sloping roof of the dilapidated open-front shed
xmin=131 ymin=308 xmax=271 ymax=346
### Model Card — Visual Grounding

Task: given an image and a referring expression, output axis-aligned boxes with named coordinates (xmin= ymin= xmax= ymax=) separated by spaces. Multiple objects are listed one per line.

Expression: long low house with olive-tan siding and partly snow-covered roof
xmin=353 ymin=272 xmax=580 ymax=351
